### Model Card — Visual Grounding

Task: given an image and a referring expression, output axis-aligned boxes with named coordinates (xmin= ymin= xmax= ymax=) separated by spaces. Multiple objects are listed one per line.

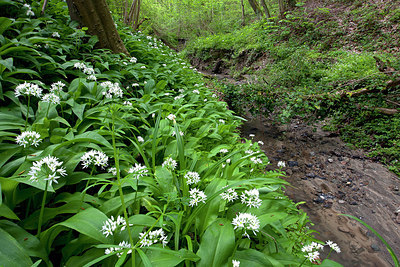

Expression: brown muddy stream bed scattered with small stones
xmin=242 ymin=118 xmax=400 ymax=267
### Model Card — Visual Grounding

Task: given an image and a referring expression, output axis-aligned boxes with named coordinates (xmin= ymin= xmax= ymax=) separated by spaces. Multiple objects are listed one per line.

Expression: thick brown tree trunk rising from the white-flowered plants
xmin=67 ymin=0 xmax=129 ymax=55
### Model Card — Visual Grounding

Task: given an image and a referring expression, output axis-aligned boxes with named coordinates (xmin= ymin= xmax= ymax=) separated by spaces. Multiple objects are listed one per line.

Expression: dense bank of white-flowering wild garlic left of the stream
xmin=0 ymin=0 xmax=339 ymax=267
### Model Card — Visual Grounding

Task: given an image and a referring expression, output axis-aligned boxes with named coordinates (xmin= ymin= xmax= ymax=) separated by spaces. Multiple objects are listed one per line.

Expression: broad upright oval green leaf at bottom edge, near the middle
xmin=196 ymin=219 xmax=235 ymax=267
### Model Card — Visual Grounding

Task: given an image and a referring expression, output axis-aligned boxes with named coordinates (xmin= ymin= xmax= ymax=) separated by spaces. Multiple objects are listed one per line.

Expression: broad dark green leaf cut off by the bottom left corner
xmin=0 ymin=228 xmax=32 ymax=267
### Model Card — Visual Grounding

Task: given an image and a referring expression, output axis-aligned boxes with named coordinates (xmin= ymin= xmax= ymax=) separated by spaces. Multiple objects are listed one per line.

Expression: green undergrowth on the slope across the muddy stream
xmin=180 ymin=1 xmax=400 ymax=176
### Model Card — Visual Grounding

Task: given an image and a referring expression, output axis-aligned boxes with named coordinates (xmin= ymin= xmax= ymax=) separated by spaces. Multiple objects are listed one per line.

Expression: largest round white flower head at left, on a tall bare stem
xmin=28 ymin=156 xmax=67 ymax=186
